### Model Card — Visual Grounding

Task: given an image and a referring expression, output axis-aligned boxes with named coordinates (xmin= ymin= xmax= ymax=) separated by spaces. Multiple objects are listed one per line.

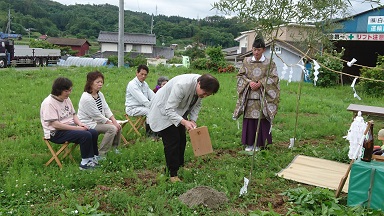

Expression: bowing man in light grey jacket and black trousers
xmin=148 ymin=74 xmax=220 ymax=182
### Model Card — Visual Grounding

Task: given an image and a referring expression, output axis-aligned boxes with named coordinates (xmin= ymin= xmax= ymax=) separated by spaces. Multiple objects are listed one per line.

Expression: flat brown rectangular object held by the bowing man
xmin=189 ymin=126 xmax=213 ymax=156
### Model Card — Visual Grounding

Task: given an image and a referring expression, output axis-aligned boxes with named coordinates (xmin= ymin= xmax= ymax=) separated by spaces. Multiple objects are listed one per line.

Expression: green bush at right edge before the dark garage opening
xmin=359 ymin=56 xmax=384 ymax=97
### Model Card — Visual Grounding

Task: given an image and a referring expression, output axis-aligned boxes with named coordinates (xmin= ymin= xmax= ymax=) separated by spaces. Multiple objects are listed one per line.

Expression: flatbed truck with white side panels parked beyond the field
xmin=0 ymin=40 xmax=61 ymax=68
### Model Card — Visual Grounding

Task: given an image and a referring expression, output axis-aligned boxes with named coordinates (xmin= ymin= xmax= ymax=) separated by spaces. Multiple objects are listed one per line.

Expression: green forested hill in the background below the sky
xmin=0 ymin=0 xmax=252 ymax=48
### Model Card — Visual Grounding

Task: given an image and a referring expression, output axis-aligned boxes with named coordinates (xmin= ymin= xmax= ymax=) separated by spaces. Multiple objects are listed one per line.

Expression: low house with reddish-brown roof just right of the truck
xmin=46 ymin=37 xmax=91 ymax=56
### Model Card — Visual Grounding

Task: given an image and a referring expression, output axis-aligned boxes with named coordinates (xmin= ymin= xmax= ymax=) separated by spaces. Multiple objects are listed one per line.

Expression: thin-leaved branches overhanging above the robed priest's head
xmin=213 ymin=0 xmax=351 ymax=44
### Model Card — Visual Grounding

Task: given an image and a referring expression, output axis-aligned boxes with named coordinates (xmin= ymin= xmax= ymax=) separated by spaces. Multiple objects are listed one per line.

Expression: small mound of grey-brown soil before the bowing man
xmin=179 ymin=186 xmax=228 ymax=209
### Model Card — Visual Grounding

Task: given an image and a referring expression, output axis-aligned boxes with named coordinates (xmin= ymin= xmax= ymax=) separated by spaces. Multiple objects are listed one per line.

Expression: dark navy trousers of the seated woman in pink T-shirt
xmin=50 ymin=129 xmax=99 ymax=159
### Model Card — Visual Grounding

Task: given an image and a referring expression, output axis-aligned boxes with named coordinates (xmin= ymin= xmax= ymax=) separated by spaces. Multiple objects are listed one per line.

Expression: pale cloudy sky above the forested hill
xmin=52 ymin=0 xmax=377 ymax=19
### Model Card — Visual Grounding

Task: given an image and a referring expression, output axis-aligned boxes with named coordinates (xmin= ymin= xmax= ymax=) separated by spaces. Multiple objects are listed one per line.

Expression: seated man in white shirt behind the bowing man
xmin=125 ymin=65 xmax=155 ymax=135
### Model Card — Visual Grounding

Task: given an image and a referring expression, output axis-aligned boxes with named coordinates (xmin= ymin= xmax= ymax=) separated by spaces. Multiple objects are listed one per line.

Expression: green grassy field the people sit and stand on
xmin=0 ymin=67 xmax=384 ymax=215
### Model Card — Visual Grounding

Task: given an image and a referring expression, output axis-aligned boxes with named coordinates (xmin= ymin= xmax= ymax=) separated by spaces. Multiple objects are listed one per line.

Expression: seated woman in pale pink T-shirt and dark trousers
xmin=40 ymin=77 xmax=99 ymax=170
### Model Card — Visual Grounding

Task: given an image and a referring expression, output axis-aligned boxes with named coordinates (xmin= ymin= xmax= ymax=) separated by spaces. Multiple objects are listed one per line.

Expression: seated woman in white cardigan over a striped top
xmin=78 ymin=71 xmax=121 ymax=156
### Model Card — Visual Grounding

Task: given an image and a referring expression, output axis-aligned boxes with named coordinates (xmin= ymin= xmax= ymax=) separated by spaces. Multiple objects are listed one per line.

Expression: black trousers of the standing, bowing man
xmin=160 ymin=124 xmax=187 ymax=177
